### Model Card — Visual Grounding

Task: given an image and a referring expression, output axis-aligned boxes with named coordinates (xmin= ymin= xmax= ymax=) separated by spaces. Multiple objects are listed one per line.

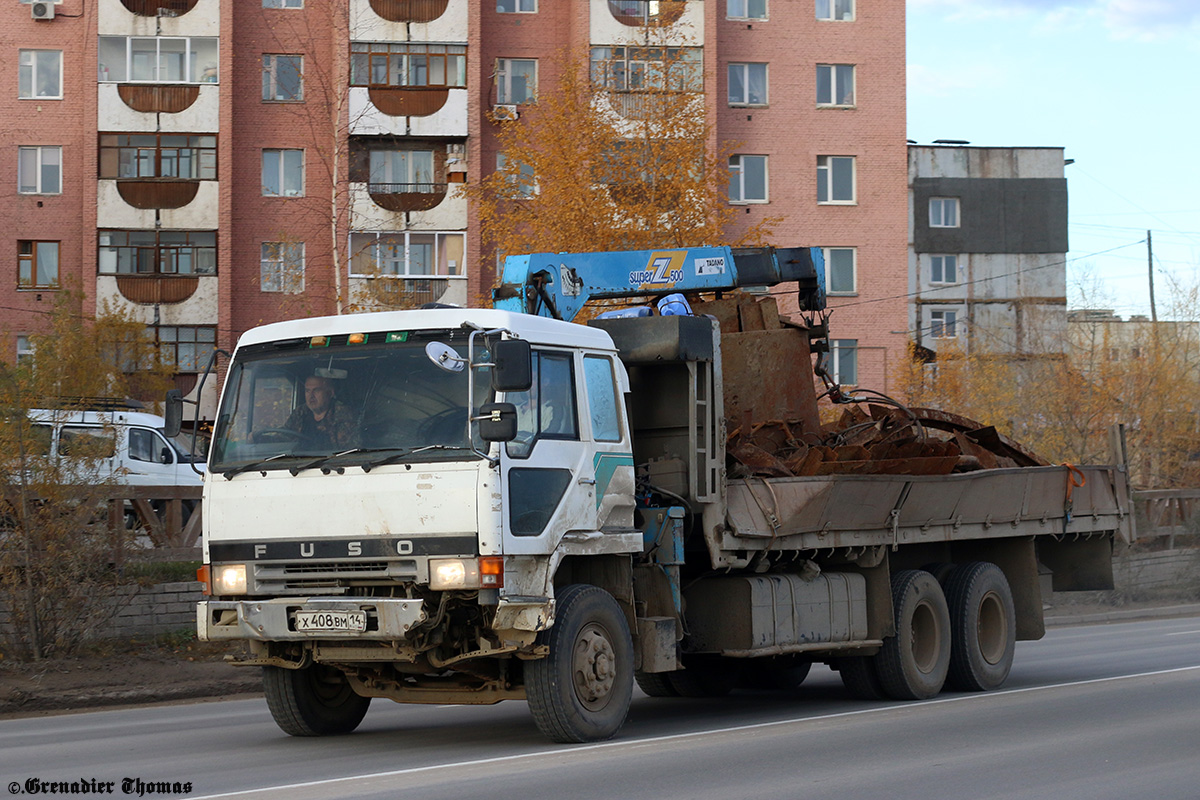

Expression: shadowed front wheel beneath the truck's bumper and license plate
xmin=263 ymin=664 xmax=371 ymax=736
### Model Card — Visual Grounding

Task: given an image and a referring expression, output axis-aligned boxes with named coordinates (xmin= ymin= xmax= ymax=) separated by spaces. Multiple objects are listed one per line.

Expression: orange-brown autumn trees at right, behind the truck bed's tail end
xmin=899 ymin=287 xmax=1200 ymax=488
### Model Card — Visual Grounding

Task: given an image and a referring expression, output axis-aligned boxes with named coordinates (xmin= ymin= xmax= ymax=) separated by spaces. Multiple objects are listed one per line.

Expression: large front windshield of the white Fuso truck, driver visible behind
xmin=209 ymin=331 xmax=491 ymax=474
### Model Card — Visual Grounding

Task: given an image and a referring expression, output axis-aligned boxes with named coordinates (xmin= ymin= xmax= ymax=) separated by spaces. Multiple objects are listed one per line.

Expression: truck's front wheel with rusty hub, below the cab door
xmin=526 ymin=584 xmax=634 ymax=742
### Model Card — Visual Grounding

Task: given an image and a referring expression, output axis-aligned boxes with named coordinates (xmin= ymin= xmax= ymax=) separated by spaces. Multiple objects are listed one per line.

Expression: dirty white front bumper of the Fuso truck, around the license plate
xmin=196 ymin=597 xmax=425 ymax=642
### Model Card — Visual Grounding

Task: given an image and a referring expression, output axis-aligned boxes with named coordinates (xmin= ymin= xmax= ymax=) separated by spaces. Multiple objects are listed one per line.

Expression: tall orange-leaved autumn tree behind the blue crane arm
xmin=464 ymin=43 xmax=778 ymax=287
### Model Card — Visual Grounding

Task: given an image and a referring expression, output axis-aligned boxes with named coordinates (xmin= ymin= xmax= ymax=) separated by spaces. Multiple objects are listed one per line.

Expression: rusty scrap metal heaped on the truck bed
xmin=696 ymin=294 xmax=1049 ymax=477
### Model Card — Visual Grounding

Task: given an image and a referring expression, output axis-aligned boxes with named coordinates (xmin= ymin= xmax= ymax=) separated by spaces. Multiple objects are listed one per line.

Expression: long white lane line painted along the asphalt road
xmin=192 ymin=664 xmax=1200 ymax=800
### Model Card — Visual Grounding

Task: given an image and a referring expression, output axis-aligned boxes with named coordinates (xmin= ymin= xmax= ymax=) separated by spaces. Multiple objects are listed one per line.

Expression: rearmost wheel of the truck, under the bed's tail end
xmin=946 ymin=561 xmax=1016 ymax=692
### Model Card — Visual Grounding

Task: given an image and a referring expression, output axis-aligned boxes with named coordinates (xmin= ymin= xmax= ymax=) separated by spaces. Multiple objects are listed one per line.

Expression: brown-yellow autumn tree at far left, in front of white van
xmin=0 ymin=297 xmax=169 ymax=660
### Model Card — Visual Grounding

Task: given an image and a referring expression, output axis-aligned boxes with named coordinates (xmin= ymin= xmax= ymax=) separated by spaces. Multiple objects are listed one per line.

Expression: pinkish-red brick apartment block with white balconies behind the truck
xmin=0 ymin=0 xmax=908 ymax=410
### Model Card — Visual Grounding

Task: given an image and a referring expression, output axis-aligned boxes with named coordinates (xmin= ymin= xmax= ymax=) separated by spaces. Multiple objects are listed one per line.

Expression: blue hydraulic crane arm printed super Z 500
xmin=492 ymin=247 xmax=826 ymax=321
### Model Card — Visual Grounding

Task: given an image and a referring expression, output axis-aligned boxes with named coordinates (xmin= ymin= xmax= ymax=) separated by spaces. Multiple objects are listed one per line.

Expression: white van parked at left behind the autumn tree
xmin=29 ymin=409 xmax=204 ymax=486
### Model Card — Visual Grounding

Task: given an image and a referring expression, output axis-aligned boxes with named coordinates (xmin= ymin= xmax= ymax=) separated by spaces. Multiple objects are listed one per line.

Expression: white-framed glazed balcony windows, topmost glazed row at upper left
xmin=100 ymin=36 xmax=220 ymax=83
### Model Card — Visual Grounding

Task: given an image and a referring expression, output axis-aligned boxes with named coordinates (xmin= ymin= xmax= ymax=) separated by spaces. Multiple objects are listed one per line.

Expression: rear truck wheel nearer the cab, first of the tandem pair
xmin=875 ymin=570 xmax=950 ymax=700
